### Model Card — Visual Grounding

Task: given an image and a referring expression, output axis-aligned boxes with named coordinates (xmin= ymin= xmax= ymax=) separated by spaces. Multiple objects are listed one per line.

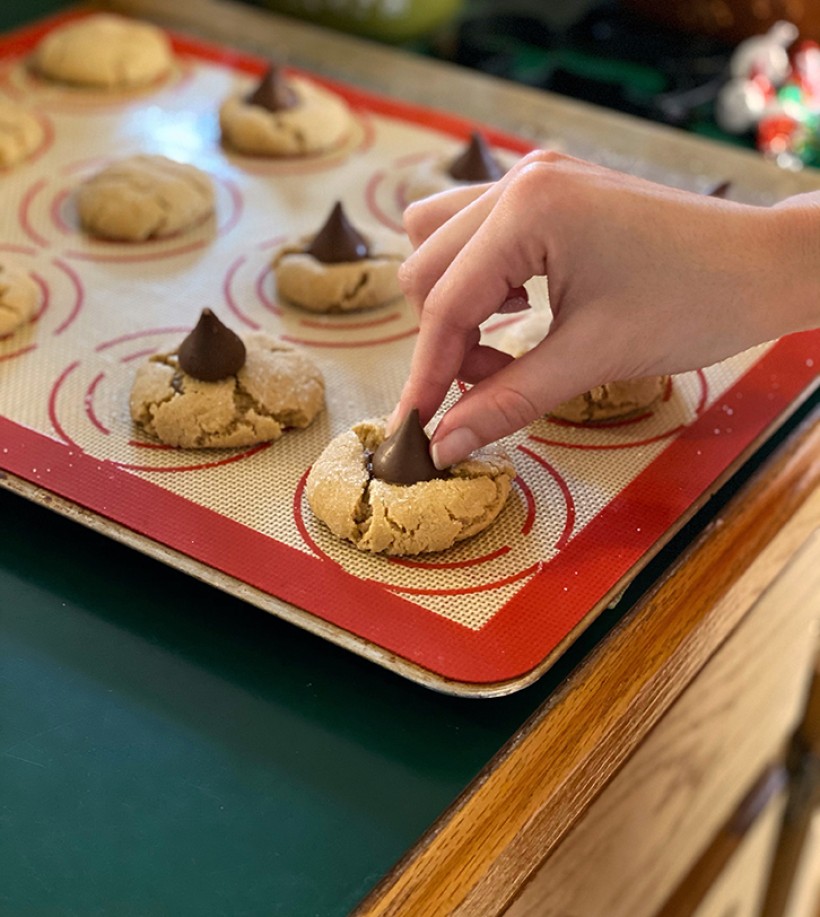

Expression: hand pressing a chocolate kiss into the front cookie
xmin=393 ymin=152 xmax=816 ymax=468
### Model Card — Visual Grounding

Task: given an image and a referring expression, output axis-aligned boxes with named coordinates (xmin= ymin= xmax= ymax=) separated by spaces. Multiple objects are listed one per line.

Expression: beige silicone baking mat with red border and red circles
xmin=0 ymin=10 xmax=820 ymax=696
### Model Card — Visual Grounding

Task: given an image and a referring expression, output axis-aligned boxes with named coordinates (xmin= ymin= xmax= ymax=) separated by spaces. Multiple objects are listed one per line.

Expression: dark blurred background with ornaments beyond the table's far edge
xmin=251 ymin=0 xmax=820 ymax=169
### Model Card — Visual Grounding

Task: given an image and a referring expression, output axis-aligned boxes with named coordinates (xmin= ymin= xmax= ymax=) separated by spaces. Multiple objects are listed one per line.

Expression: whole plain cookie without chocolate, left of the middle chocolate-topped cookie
xmin=76 ymin=154 xmax=214 ymax=242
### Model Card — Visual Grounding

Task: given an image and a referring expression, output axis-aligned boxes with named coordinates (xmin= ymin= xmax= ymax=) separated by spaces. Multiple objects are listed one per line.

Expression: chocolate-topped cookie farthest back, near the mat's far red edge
xmin=219 ymin=67 xmax=353 ymax=156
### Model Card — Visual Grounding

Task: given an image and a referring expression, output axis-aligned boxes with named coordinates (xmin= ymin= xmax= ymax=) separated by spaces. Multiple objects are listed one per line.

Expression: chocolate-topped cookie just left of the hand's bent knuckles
xmin=272 ymin=202 xmax=405 ymax=312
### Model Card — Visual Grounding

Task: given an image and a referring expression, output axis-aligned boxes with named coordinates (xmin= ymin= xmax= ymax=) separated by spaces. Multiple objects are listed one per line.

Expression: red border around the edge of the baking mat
xmin=0 ymin=12 xmax=820 ymax=686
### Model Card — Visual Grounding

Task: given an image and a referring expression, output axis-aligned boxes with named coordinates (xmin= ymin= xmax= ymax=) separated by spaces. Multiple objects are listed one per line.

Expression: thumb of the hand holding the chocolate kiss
xmin=430 ymin=329 xmax=611 ymax=469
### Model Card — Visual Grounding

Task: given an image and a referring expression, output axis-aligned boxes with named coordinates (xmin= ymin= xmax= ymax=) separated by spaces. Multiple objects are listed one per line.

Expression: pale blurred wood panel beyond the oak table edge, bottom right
xmin=506 ymin=537 xmax=820 ymax=917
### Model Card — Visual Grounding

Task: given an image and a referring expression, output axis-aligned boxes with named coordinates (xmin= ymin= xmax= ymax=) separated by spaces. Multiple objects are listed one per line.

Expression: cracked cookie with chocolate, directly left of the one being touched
xmin=130 ymin=310 xmax=325 ymax=449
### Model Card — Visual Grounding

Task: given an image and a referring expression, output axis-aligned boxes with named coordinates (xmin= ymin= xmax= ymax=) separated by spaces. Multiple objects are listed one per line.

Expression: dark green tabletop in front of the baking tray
xmin=0 ymin=491 xmax=608 ymax=915
